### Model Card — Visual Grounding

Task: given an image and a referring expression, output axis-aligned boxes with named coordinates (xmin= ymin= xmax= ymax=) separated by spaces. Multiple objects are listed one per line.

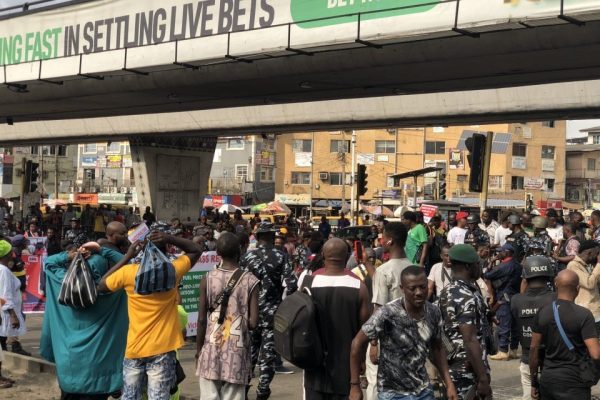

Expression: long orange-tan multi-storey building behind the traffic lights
xmin=275 ymin=121 xmax=566 ymax=207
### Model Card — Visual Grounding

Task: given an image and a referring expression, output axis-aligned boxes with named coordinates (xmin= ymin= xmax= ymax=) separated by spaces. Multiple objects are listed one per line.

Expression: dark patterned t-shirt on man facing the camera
xmin=362 ymin=298 xmax=443 ymax=395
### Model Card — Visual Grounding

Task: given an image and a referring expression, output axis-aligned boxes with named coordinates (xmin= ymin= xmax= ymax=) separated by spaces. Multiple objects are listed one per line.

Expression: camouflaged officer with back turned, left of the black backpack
xmin=240 ymin=222 xmax=297 ymax=400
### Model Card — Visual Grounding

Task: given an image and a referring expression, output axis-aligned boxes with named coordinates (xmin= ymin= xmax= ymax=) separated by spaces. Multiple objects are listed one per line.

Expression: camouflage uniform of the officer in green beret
xmin=439 ymin=279 xmax=490 ymax=400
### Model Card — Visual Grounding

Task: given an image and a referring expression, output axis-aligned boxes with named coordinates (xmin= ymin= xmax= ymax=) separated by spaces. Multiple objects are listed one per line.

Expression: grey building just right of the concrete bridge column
xmin=208 ymin=135 xmax=275 ymax=205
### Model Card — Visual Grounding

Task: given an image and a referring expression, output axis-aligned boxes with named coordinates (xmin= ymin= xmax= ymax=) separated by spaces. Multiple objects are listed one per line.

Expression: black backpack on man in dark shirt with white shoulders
xmin=273 ymin=275 xmax=326 ymax=369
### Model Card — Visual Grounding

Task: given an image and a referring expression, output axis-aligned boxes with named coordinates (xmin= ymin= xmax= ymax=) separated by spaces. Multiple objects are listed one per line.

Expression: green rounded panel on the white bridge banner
xmin=290 ymin=0 xmax=441 ymax=28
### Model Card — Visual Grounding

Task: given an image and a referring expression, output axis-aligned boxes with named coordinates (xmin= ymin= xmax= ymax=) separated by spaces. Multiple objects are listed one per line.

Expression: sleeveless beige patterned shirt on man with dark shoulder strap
xmin=196 ymin=268 xmax=258 ymax=385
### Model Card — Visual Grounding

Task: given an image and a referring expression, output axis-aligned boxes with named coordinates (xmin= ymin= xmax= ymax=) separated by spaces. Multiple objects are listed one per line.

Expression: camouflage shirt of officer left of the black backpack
xmin=240 ymin=244 xmax=297 ymax=321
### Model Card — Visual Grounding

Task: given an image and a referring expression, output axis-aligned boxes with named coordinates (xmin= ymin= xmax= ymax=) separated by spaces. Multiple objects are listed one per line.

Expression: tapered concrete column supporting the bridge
xmin=129 ymin=134 xmax=216 ymax=222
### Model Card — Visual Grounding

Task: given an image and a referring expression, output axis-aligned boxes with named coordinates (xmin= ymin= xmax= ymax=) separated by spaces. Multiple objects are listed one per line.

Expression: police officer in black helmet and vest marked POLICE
xmin=510 ymin=255 xmax=555 ymax=400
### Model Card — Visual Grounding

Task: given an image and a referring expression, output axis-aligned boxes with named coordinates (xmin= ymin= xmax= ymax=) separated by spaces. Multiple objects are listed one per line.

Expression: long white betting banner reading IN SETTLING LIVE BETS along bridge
xmin=0 ymin=0 xmax=600 ymax=82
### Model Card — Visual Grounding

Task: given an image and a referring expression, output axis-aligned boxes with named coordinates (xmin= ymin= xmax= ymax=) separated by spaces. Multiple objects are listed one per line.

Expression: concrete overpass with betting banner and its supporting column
xmin=0 ymin=0 xmax=600 ymax=216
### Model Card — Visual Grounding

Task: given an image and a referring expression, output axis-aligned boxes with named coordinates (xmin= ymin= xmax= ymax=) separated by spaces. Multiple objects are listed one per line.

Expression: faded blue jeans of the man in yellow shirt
xmin=121 ymin=351 xmax=176 ymax=400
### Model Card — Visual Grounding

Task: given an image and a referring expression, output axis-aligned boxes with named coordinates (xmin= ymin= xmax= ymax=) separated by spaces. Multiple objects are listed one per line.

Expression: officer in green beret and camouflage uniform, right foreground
xmin=439 ymin=244 xmax=492 ymax=400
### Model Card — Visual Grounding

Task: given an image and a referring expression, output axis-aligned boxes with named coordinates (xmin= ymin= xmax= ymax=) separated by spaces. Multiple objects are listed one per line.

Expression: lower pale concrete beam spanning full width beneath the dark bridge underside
xmin=0 ymin=80 xmax=600 ymax=145
